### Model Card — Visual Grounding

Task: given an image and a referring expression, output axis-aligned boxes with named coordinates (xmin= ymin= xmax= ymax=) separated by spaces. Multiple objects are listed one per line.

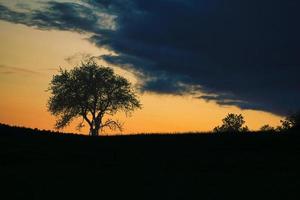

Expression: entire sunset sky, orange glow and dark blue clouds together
xmin=0 ymin=0 xmax=300 ymax=134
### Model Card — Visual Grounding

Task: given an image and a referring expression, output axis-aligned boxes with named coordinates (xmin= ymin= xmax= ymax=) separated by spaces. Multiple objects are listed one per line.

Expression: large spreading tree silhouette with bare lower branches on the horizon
xmin=47 ymin=59 xmax=141 ymax=136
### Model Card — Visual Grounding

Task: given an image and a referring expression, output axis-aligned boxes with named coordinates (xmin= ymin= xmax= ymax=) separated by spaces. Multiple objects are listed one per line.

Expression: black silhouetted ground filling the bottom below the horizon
xmin=0 ymin=125 xmax=300 ymax=200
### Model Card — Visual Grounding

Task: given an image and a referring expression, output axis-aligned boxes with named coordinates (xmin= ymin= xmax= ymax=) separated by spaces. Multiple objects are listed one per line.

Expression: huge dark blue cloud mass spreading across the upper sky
xmin=0 ymin=0 xmax=300 ymax=114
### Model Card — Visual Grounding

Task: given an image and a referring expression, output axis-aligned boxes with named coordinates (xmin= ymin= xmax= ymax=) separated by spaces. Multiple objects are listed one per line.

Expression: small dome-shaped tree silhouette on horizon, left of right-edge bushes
xmin=213 ymin=113 xmax=249 ymax=132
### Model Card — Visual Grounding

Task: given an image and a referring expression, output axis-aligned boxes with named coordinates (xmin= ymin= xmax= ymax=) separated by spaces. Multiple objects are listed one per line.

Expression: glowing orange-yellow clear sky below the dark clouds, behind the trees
xmin=0 ymin=21 xmax=280 ymax=134
